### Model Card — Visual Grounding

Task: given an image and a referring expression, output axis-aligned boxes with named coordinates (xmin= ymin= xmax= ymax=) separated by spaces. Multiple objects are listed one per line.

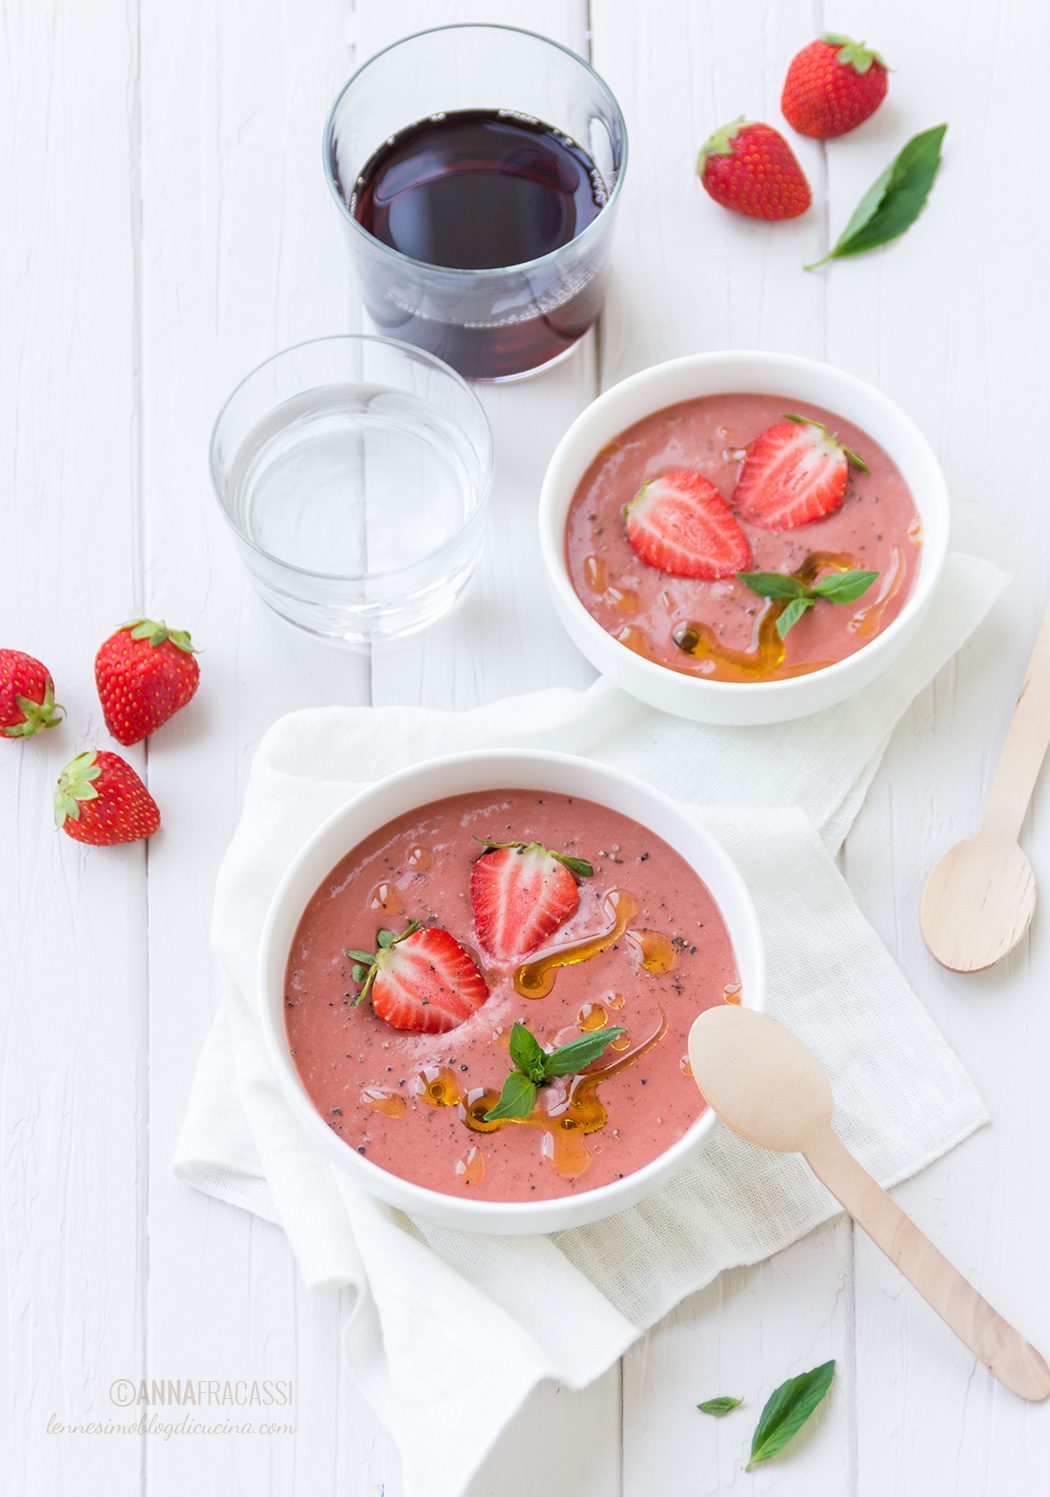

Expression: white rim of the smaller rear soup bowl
xmin=539 ymin=349 xmax=950 ymax=705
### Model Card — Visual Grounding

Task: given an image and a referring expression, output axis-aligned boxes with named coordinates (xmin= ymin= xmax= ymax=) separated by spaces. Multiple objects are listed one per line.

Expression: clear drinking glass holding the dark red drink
xmin=324 ymin=24 xmax=628 ymax=380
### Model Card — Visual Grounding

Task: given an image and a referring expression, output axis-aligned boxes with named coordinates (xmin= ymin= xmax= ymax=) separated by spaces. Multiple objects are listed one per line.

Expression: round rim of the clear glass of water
xmin=208 ymin=332 xmax=496 ymax=584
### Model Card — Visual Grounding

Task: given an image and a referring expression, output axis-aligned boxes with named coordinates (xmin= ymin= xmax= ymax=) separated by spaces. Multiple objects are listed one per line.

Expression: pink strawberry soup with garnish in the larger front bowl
xmin=285 ymin=789 xmax=740 ymax=1201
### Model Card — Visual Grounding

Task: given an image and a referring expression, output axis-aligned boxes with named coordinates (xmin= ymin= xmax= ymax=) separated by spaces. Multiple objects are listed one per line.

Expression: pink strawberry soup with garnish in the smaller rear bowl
xmin=565 ymin=394 xmax=923 ymax=681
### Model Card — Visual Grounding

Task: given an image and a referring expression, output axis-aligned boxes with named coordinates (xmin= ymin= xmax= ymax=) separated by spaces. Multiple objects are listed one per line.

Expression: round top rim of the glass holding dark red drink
xmin=321 ymin=21 xmax=631 ymax=281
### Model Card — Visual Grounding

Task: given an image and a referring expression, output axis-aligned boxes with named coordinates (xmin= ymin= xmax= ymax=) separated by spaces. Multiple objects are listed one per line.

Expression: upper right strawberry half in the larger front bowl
xmin=470 ymin=841 xmax=595 ymax=961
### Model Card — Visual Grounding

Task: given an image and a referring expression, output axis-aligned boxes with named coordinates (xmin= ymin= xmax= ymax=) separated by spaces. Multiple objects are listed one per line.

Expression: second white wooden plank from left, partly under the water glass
xmin=141 ymin=0 xmax=367 ymax=1497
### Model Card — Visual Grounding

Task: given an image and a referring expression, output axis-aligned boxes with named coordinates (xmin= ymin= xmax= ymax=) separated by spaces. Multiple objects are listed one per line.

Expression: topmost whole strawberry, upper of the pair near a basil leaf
xmin=780 ymin=34 xmax=890 ymax=141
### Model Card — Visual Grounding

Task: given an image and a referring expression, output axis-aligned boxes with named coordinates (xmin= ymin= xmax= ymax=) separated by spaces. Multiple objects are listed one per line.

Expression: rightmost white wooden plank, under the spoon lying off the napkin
xmin=822 ymin=0 xmax=1050 ymax=1497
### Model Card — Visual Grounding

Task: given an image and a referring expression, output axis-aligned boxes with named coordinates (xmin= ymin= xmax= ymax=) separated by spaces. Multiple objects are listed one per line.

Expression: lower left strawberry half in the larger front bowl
xmin=346 ymin=921 xmax=488 ymax=1034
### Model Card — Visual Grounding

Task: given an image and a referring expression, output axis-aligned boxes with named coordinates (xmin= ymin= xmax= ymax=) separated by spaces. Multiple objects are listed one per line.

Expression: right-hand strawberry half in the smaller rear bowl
xmin=732 ymin=416 xmax=867 ymax=530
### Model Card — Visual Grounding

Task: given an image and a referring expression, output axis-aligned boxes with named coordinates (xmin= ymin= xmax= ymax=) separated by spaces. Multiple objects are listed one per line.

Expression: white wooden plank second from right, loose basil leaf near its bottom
xmin=593 ymin=0 xmax=852 ymax=1497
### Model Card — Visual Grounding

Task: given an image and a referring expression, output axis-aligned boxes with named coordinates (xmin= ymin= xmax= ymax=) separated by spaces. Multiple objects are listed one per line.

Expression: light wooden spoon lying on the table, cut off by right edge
xmin=918 ymin=608 xmax=1050 ymax=972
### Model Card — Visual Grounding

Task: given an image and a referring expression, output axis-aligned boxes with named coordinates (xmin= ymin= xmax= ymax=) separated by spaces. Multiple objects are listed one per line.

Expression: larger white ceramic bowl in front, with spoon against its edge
xmin=259 ymin=750 xmax=765 ymax=1234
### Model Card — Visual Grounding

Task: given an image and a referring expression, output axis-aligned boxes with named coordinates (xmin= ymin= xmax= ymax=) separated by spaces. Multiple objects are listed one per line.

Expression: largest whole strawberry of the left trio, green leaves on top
xmin=94 ymin=618 xmax=201 ymax=744
